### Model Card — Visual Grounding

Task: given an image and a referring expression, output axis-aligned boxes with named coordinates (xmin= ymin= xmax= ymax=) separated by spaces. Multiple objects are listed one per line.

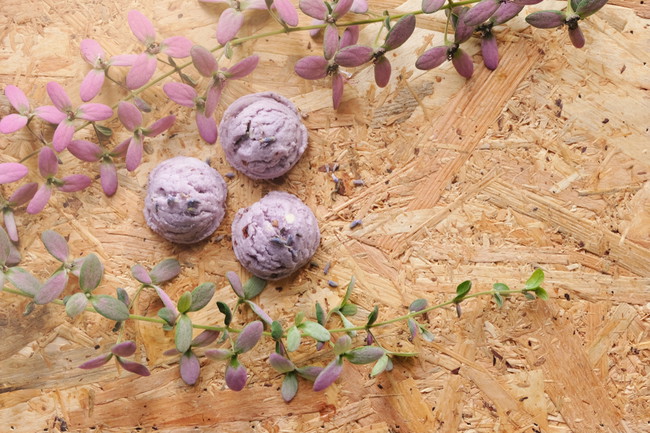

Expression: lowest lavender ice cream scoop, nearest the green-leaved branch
xmin=232 ymin=191 xmax=320 ymax=280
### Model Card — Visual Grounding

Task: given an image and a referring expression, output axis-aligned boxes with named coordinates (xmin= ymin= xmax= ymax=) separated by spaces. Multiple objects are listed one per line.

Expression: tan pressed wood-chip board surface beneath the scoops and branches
xmin=0 ymin=0 xmax=650 ymax=433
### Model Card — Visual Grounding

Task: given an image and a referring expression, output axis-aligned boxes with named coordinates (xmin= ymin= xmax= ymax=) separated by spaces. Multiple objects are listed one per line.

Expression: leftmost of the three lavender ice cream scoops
xmin=144 ymin=156 xmax=226 ymax=244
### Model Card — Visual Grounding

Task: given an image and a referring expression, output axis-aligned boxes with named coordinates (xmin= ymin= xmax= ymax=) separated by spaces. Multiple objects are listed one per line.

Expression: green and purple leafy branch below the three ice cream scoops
xmin=0 ymin=228 xmax=548 ymax=402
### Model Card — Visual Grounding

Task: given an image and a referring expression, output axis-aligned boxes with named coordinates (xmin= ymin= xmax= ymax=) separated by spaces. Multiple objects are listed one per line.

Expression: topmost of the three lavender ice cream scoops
xmin=219 ymin=92 xmax=308 ymax=179
